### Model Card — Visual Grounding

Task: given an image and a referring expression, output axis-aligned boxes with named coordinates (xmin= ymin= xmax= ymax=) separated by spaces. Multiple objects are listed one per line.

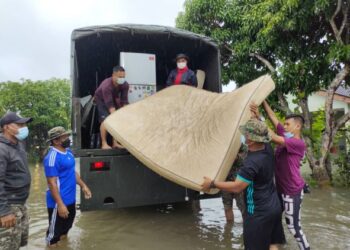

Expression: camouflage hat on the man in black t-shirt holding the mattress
xmin=239 ymin=119 xmax=271 ymax=142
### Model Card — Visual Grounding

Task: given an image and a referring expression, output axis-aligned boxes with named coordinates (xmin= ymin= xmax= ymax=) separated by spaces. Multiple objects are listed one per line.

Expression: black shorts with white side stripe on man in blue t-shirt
xmin=46 ymin=203 xmax=75 ymax=245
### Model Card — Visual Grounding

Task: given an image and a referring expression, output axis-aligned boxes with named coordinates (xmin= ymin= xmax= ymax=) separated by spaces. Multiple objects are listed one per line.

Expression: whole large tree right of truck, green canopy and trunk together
xmin=176 ymin=0 xmax=350 ymax=184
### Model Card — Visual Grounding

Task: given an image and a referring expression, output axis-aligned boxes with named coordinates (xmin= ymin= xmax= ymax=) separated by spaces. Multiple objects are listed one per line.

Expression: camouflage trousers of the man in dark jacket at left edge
xmin=0 ymin=204 xmax=29 ymax=250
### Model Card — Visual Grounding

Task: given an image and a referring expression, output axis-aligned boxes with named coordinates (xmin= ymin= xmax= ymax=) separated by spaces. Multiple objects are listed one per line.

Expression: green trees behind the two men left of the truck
xmin=0 ymin=78 xmax=70 ymax=158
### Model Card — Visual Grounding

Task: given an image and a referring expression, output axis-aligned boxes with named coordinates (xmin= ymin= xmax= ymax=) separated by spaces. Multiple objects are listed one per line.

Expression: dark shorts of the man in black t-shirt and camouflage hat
xmin=243 ymin=210 xmax=286 ymax=250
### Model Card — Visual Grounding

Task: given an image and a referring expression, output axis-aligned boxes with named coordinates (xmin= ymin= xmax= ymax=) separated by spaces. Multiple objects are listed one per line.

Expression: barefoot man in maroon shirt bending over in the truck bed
xmin=95 ymin=66 xmax=129 ymax=149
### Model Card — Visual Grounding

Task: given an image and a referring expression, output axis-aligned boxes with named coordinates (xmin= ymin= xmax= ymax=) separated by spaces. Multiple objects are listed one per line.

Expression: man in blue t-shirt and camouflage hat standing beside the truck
xmin=43 ymin=127 xmax=91 ymax=246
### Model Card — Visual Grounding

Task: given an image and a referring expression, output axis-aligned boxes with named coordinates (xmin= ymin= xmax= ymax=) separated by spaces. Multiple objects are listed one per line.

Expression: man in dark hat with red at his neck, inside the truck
xmin=166 ymin=54 xmax=197 ymax=87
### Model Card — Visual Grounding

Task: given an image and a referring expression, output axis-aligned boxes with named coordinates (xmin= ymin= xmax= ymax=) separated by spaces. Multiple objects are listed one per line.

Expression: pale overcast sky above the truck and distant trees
xmin=0 ymin=0 xmax=235 ymax=91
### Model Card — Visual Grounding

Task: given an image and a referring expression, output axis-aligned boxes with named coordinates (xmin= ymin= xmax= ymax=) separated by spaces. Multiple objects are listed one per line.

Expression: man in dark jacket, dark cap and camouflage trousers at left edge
xmin=0 ymin=112 xmax=32 ymax=250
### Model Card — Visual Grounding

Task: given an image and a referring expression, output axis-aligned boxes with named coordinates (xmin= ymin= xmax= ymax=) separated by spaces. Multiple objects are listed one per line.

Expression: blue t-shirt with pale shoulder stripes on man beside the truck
xmin=44 ymin=147 xmax=77 ymax=208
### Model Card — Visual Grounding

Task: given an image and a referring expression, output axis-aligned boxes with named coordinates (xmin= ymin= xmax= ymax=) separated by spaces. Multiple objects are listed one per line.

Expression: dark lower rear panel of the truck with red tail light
xmin=77 ymin=154 xmax=199 ymax=211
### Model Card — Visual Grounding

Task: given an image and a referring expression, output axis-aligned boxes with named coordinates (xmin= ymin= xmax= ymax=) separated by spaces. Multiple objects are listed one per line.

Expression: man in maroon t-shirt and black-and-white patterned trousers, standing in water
xmin=251 ymin=101 xmax=310 ymax=249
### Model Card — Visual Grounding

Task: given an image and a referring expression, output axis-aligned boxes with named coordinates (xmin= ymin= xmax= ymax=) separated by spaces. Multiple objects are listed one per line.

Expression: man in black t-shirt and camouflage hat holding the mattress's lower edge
xmin=202 ymin=119 xmax=285 ymax=250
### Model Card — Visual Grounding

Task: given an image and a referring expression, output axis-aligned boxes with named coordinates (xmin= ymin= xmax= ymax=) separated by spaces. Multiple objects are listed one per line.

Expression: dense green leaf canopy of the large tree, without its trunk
xmin=176 ymin=0 xmax=342 ymax=96
